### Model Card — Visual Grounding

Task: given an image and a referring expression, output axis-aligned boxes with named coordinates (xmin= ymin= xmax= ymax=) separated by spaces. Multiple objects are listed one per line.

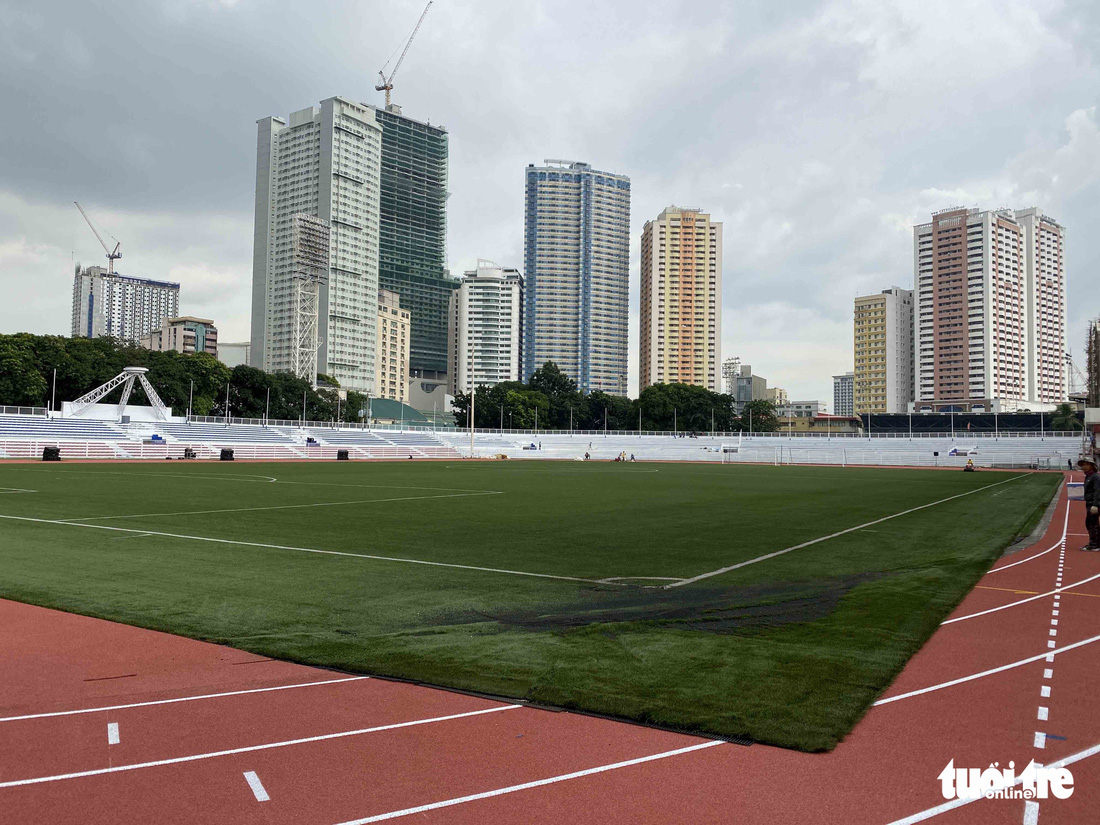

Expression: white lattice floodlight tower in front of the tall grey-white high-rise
xmin=290 ymin=212 xmax=331 ymax=387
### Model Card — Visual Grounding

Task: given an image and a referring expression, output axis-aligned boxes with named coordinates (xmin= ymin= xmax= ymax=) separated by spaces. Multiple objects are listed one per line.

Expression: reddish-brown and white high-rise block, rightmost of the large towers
xmin=913 ymin=207 xmax=1067 ymax=411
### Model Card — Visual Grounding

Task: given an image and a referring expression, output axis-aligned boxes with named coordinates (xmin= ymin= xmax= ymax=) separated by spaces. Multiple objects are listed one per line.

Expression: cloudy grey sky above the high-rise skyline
xmin=0 ymin=0 xmax=1100 ymax=408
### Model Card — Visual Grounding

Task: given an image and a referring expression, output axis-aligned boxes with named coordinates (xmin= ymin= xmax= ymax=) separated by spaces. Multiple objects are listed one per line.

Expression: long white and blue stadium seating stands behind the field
xmin=0 ymin=415 xmax=1081 ymax=470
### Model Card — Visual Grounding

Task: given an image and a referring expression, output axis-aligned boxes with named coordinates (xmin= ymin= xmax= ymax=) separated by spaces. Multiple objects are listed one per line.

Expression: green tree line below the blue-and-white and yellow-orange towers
xmin=454 ymin=361 xmax=779 ymax=432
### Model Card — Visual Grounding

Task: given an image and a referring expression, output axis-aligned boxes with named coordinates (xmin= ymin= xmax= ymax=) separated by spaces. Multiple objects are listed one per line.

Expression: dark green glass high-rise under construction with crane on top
xmin=374 ymin=103 xmax=457 ymax=378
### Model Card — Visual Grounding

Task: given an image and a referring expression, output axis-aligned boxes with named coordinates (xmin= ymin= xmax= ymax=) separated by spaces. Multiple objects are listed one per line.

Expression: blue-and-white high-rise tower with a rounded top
xmin=524 ymin=161 xmax=630 ymax=396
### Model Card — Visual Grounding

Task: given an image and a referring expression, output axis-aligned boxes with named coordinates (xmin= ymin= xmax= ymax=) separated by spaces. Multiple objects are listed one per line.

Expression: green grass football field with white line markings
xmin=0 ymin=461 xmax=1059 ymax=750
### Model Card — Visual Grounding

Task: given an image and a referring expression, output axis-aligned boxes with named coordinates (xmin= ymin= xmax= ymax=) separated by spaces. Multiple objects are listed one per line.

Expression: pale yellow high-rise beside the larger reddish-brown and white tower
xmin=853 ymin=286 xmax=913 ymax=415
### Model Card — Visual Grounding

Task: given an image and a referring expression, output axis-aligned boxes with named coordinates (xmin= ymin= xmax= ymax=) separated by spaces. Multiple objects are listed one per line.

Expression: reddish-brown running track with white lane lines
xmin=0 ymin=475 xmax=1100 ymax=825
